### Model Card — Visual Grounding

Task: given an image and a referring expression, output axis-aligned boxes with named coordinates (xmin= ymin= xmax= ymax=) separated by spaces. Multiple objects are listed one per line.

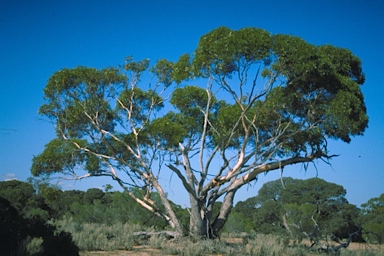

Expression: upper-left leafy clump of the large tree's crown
xmin=39 ymin=67 xmax=125 ymax=133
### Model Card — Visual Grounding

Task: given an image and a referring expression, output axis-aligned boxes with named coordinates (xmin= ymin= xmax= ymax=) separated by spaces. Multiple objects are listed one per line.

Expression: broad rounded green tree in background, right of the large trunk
xmin=234 ymin=177 xmax=359 ymax=239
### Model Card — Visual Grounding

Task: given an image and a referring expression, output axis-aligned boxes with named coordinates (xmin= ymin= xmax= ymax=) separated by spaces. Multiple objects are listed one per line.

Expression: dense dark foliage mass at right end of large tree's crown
xmin=274 ymin=35 xmax=368 ymax=142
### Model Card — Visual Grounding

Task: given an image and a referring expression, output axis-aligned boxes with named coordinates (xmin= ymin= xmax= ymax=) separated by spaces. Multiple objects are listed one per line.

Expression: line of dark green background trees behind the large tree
xmin=0 ymin=177 xmax=384 ymax=255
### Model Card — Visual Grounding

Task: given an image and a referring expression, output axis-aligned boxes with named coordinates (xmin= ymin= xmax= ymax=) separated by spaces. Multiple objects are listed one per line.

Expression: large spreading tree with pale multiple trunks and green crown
xmin=32 ymin=27 xmax=368 ymax=237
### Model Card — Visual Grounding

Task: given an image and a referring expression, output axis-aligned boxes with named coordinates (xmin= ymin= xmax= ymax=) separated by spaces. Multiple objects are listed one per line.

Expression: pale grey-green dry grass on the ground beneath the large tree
xmin=56 ymin=219 xmax=384 ymax=256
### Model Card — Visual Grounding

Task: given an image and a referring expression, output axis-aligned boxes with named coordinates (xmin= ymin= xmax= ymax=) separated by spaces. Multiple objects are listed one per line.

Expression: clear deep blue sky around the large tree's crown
xmin=0 ymin=0 xmax=384 ymax=206
